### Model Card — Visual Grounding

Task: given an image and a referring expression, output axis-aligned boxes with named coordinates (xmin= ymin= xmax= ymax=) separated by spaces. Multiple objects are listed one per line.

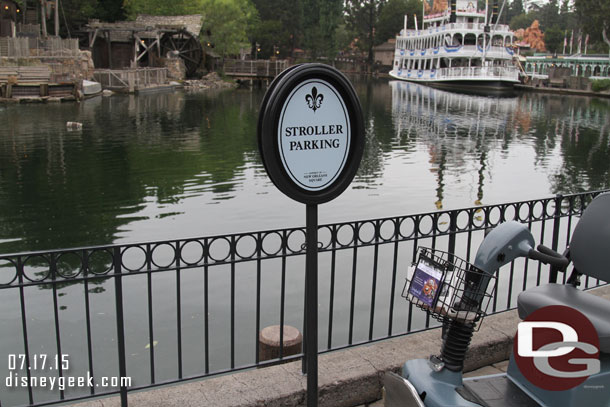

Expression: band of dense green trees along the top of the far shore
xmin=42 ymin=0 xmax=610 ymax=64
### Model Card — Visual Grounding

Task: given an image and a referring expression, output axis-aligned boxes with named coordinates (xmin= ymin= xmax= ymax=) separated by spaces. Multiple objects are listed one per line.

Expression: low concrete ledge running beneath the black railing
xmin=73 ymin=286 xmax=610 ymax=407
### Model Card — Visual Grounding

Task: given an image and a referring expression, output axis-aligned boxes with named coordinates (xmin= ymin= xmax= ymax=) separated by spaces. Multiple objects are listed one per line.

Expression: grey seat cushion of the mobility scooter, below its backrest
xmin=517 ymin=284 xmax=610 ymax=353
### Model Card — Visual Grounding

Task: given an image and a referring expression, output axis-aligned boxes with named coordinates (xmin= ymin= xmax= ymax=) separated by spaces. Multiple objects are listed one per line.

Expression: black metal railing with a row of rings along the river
xmin=0 ymin=192 xmax=604 ymax=406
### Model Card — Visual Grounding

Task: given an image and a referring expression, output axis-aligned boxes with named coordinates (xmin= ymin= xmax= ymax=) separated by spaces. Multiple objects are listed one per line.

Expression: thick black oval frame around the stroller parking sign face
xmin=257 ymin=63 xmax=364 ymax=204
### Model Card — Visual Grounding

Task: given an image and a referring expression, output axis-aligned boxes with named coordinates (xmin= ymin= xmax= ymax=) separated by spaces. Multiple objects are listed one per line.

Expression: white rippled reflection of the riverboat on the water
xmin=390 ymin=81 xmax=517 ymax=209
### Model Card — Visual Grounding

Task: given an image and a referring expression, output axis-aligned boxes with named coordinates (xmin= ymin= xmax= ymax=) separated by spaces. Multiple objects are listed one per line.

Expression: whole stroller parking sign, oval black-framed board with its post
xmin=257 ymin=64 xmax=364 ymax=407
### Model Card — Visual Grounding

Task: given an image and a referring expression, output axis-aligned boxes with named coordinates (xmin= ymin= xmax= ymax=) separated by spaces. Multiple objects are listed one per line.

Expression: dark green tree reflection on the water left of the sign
xmin=0 ymin=93 xmax=256 ymax=252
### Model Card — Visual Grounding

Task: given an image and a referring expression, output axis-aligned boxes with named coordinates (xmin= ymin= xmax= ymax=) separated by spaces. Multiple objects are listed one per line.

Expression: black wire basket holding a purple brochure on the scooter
xmin=402 ymin=247 xmax=496 ymax=326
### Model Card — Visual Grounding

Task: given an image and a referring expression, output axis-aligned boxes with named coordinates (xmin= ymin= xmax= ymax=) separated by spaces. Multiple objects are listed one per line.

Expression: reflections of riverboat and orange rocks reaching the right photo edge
xmin=390 ymin=81 xmax=610 ymax=209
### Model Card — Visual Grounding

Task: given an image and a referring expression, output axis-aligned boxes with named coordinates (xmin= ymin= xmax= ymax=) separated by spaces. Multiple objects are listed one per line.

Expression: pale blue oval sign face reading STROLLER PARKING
xmin=277 ymin=79 xmax=351 ymax=191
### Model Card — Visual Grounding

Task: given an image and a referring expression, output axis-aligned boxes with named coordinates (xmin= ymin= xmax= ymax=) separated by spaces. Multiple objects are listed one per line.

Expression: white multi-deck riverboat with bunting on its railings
xmin=390 ymin=0 xmax=519 ymax=91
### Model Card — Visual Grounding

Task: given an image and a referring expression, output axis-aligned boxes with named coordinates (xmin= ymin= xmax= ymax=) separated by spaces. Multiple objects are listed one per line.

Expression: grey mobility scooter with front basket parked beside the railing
xmin=383 ymin=193 xmax=610 ymax=407
